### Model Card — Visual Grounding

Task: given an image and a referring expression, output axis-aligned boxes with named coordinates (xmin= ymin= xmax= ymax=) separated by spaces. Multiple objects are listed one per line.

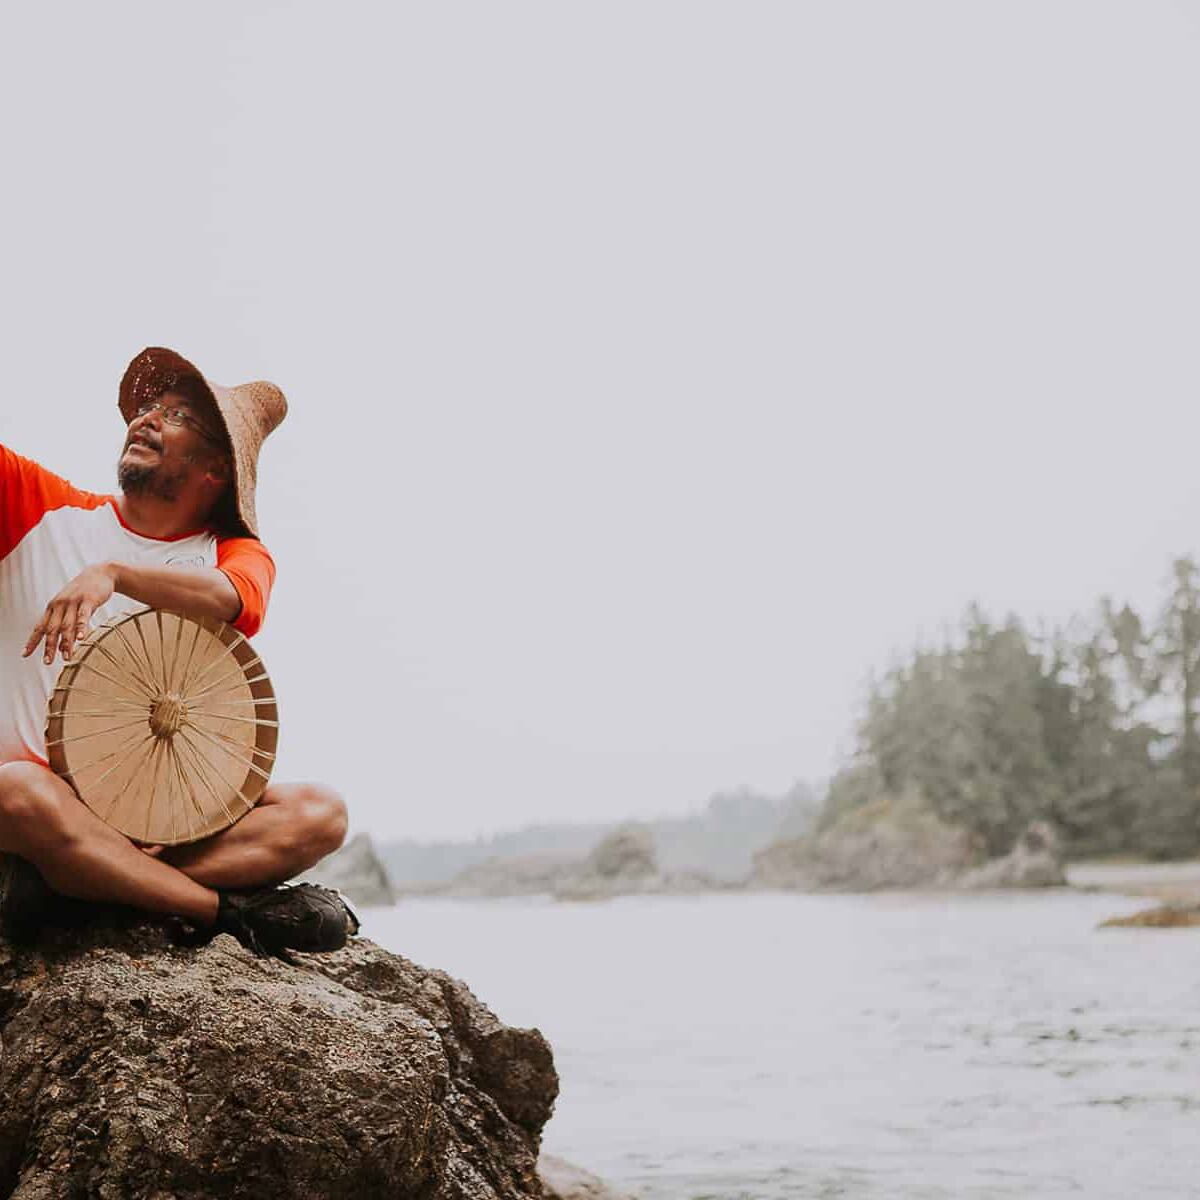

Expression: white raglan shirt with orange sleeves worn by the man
xmin=0 ymin=445 xmax=275 ymax=763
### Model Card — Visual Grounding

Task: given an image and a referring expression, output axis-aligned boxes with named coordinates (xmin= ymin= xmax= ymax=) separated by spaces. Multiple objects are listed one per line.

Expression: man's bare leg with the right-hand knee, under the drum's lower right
xmin=158 ymin=784 xmax=346 ymax=888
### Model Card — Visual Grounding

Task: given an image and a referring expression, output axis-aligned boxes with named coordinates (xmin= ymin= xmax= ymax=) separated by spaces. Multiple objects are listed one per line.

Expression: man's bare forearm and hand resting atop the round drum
xmin=24 ymin=563 xmax=241 ymax=664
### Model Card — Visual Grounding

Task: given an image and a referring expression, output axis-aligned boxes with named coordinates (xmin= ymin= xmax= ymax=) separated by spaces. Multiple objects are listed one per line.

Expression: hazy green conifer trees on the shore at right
xmin=821 ymin=558 xmax=1200 ymax=858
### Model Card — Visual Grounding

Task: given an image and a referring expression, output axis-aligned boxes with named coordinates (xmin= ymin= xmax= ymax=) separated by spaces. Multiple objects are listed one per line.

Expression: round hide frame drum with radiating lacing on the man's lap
xmin=46 ymin=610 xmax=280 ymax=846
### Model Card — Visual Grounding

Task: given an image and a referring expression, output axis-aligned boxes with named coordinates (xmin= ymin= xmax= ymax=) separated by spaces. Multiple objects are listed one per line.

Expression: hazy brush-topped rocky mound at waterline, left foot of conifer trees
xmin=752 ymin=799 xmax=982 ymax=892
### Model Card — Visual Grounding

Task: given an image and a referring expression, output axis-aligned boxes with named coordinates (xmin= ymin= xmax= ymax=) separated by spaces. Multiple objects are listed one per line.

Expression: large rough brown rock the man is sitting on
xmin=0 ymin=924 xmax=558 ymax=1200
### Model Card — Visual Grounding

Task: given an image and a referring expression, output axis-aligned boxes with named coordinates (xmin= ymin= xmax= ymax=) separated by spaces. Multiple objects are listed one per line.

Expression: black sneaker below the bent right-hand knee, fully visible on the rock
xmin=214 ymin=883 xmax=359 ymax=958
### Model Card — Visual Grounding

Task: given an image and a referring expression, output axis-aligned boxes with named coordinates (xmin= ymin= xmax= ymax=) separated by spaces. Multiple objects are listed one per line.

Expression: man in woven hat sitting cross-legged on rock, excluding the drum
xmin=0 ymin=349 xmax=358 ymax=953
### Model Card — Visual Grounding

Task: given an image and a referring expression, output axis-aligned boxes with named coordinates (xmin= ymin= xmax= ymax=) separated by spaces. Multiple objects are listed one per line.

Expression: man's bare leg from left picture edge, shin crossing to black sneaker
xmin=0 ymin=762 xmax=217 ymax=925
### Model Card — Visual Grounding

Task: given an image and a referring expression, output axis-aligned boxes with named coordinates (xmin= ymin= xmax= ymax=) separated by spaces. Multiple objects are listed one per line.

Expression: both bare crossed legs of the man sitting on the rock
xmin=0 ymin=762 xmax=346 ymax=925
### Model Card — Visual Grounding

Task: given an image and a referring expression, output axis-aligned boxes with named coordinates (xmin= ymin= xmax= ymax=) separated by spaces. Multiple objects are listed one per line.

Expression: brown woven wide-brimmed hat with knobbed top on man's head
xmin=116 ymin=346 xmax=288 ymax=538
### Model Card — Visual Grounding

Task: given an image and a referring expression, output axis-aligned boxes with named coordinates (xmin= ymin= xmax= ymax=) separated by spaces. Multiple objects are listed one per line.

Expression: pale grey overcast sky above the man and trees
xmin=0 ymin=0 xmax=1200 ymax=838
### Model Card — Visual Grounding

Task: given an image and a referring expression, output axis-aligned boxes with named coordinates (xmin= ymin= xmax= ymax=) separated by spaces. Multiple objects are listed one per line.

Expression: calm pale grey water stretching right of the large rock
xmin=365 ymin=892 xmax=1200 ymax=1200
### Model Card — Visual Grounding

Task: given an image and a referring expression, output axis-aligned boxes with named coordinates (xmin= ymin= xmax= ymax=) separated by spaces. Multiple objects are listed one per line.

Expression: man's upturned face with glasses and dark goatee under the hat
xmin=116 ymin=391 xmax=221 ymax=500
